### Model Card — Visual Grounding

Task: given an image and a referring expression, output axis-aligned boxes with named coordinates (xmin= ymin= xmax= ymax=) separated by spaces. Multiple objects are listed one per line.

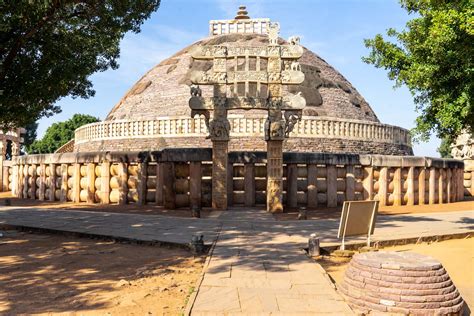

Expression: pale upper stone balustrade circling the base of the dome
xmin=75 ymin=116 xmax=411 ymax=146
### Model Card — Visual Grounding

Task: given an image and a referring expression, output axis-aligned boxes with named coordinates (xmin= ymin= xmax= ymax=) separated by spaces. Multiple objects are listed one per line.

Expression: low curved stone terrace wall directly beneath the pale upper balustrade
xmin=75 ymin=137 xmax=413 ymax=156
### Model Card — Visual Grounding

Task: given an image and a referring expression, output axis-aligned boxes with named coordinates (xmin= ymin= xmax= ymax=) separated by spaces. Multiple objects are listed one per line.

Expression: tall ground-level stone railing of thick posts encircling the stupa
xmin=2 ymin=149 xmax=464 ymax=208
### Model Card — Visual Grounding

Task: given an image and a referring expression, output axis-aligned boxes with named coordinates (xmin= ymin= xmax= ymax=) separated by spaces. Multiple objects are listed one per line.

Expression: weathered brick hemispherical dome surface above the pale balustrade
xmin=106 ymin=34 xmax=379 ymax=122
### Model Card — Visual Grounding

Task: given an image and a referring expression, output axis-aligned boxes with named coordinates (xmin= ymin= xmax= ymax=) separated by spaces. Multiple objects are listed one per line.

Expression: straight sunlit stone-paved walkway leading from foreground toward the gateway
xmin=191 ymin=215 xmax=352 ymax=315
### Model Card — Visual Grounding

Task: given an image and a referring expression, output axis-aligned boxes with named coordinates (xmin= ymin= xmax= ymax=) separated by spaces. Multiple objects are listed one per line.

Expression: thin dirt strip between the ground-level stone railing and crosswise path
xmin=0 ymin=192 xmax=474 ymax=221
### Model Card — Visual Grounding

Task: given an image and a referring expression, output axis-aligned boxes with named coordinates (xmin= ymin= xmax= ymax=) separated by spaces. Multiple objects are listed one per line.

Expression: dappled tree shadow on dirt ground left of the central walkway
xmin=0 ymin=231 xmax=199 ymax=315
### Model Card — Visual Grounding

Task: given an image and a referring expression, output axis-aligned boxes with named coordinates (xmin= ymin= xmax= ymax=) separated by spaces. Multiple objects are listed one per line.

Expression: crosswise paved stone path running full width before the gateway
xmin=0 ymin=203 xmax=474 ymax=248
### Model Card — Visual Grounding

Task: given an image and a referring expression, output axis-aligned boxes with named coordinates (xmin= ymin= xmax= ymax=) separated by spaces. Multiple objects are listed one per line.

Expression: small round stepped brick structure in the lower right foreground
xmin=340 ymin=251 xmax=464 ymax=315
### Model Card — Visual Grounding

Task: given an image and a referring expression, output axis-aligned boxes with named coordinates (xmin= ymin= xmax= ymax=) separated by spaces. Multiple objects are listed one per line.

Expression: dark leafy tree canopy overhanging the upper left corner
xmin=0 ymin=0 xmax=160 ymax=128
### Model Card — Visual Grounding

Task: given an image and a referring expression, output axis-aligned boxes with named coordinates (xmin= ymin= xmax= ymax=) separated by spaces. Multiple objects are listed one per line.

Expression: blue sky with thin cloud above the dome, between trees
xmin=38 ymin=0 xmax=439 ymax=156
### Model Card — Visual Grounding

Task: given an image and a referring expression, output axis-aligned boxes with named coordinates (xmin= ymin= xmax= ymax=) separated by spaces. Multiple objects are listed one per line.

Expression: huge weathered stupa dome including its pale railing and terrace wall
xmin=75 ymin=19 xmax=412 ymax=155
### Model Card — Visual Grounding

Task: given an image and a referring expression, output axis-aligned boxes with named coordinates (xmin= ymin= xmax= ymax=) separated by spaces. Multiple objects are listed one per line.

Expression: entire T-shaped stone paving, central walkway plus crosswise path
xmin=0 ymin=207 xmax=474 ymax=315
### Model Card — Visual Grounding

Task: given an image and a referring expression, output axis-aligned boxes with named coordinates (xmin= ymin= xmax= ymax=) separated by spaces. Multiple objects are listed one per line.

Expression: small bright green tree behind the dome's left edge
xmin=26 ymin=114 xmax=99 ymax=154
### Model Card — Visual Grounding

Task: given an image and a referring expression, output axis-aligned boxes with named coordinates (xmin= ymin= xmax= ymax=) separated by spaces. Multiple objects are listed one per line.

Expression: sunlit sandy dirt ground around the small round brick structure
xmin=318 ymin=238 xmax=474 ymax=311
